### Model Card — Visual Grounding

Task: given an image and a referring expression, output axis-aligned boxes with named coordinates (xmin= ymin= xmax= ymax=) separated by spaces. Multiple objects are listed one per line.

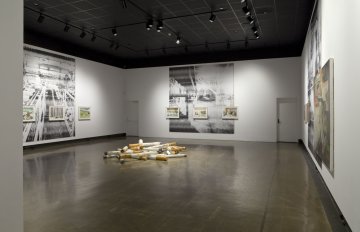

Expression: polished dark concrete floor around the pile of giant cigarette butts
xmin=24 ymin=138 xmax=333 ymax=232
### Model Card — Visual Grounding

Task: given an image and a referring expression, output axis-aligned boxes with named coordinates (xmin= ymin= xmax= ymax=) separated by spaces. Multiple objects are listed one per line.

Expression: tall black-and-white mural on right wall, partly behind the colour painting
xmin=307 ymin=2 xmax=322 ymax=167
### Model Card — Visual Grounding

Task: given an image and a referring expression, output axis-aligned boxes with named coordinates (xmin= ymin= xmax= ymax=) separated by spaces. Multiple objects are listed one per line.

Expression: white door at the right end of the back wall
xmin=277 ymin=98 xmax=299 ymax=142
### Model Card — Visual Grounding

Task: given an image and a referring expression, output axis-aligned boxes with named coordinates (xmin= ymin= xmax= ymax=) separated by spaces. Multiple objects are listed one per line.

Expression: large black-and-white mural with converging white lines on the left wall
xmin=23 ymin=47 xmax=75 ymax=142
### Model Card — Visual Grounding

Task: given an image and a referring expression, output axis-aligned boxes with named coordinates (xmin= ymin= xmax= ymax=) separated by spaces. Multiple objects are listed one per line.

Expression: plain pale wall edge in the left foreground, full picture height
xmin=0 ymin=0 xmax=24 ymax=232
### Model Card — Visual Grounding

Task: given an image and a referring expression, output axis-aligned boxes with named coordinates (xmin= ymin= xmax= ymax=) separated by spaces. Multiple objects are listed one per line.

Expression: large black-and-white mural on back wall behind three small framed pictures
xmin=169 ymin=63 xmax=234 ymax=134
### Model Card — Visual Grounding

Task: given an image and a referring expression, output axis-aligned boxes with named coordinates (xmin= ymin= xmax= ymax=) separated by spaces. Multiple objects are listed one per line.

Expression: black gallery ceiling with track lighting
xmin=24 ymin=0 xmax=314 ymax=68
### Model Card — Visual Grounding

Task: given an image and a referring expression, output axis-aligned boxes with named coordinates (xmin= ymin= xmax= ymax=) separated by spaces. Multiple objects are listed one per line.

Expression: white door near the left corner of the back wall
xmin=126 ymin=101 xmax=139 ymax=136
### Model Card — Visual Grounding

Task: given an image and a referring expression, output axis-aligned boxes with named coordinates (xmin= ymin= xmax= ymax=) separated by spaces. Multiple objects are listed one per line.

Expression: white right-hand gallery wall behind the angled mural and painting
xmin=302 ymin=0 xmax=360 ymax=231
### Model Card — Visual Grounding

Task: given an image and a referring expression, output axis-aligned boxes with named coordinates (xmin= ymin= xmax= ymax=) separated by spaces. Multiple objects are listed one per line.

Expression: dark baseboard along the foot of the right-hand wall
xmin=298 ymin=139 xmax=352 ymax=232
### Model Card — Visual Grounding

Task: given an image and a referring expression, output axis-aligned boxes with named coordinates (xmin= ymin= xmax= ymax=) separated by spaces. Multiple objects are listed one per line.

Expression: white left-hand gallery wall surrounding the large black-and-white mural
xmin=23 ymin=46 xmax=125 ymax=146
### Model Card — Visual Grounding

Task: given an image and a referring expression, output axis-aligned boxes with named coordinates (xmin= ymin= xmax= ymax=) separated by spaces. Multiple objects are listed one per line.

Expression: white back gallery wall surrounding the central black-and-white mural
xmin=126 ymin=58 xmax=301 ymax=142
